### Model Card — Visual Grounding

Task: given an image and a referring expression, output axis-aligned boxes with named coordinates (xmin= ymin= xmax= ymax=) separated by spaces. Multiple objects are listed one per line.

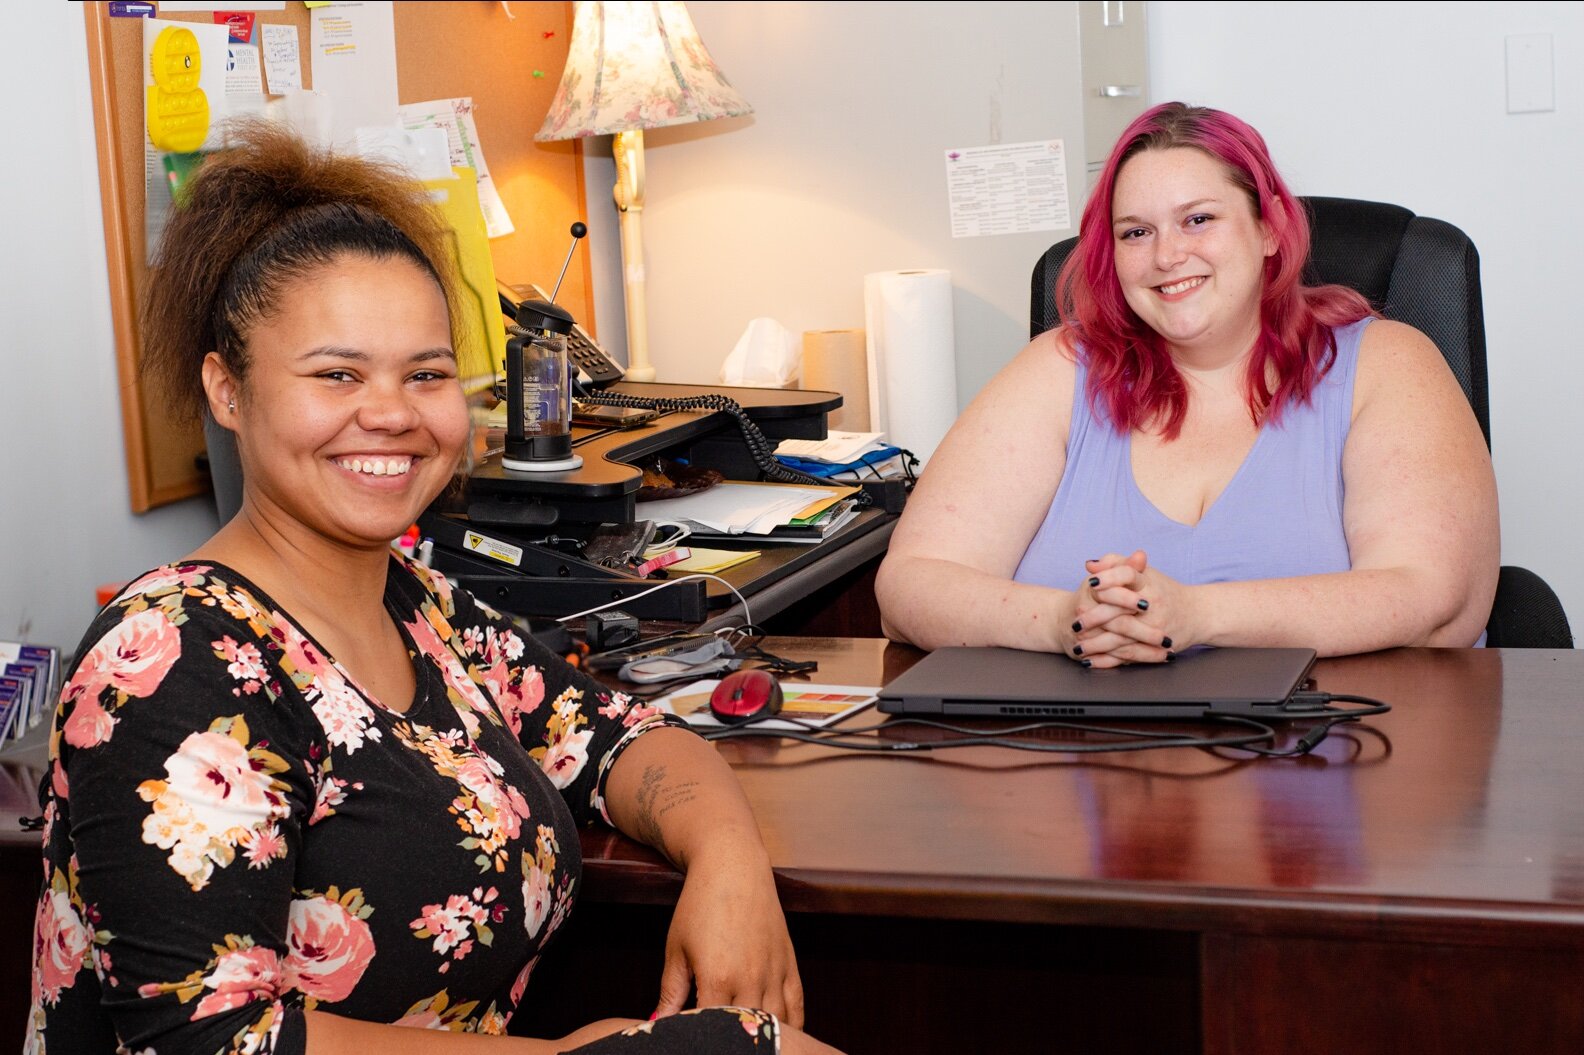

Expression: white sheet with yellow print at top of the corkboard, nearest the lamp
xmin=307 ymin=0 xmax=396 ymax=150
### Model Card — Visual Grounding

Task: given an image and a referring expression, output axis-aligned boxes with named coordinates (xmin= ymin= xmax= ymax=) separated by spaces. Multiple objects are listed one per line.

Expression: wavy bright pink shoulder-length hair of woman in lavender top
xmin=1057 ymin=103 xmax=1375 ymax=440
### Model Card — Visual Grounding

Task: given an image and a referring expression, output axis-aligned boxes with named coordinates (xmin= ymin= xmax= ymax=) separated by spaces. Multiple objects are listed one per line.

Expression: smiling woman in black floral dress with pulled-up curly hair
xmin=29 ymin=127 xmax=832 ymax=1055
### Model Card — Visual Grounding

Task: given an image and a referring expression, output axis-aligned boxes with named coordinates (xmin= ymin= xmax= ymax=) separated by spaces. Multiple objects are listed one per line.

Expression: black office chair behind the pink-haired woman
xmin=1028 ymin=198 xmax=1573 ymax=648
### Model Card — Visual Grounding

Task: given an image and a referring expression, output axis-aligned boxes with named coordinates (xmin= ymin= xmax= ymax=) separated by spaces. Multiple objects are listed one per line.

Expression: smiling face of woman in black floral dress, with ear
xmin=204 ymin=255 xmax=469 ymax=548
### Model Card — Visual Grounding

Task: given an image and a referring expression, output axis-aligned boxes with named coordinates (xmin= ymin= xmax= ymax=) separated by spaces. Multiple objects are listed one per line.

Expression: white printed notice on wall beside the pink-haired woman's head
xmin=946 ymin=139 xmax=1072 ymax=238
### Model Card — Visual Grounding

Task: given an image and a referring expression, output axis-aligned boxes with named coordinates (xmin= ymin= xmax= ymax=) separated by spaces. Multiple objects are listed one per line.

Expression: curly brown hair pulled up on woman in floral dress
xmin=141 ymin=120 xmax=464 ymax=421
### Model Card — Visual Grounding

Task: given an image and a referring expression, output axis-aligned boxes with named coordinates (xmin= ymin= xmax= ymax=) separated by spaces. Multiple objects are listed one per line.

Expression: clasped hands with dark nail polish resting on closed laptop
xmin=1061 ymin=550 xmax=1196 ymax=667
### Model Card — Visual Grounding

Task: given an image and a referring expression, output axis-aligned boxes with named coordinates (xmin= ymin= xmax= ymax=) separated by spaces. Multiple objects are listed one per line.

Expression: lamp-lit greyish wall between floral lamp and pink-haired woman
xmin=588 ymin=0 xmax=1083 ymax=401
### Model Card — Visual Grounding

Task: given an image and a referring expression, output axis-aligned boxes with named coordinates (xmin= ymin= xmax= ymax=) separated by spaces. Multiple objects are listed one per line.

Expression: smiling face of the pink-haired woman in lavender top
xmin=1110 ymin=147 xmax=1277 ymax=360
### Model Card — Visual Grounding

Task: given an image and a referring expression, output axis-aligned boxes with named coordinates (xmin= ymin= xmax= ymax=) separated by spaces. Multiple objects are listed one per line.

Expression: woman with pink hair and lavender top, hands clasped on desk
xmin=876 ymin=103 xmax=1500 ymax=667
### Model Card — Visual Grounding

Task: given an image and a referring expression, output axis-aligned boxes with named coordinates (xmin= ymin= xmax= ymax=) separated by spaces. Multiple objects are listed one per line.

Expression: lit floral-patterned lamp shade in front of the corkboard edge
xmin=534 ymin=0 xmax=754 ymax=139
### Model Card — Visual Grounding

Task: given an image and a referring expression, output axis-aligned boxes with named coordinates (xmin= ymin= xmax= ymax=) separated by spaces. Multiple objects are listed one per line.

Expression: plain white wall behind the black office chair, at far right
xmin=1150 ymin=0 xmax=1584 ymax=638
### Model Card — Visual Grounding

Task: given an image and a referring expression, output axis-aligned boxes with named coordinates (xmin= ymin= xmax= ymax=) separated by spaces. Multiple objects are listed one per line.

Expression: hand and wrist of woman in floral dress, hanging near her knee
xmin=654 ymin=841 xmax=803 ymax=1026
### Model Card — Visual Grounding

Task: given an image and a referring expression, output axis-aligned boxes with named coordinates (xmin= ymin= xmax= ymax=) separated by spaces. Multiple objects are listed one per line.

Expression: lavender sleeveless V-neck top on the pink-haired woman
xmin=1012 ymin=318 xmax=1370 ymax=589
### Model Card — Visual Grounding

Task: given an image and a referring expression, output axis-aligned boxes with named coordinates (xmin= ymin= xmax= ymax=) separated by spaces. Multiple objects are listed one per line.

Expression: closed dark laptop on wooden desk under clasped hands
xmin=879 ymin=648 xmax=1315 ymax=719
